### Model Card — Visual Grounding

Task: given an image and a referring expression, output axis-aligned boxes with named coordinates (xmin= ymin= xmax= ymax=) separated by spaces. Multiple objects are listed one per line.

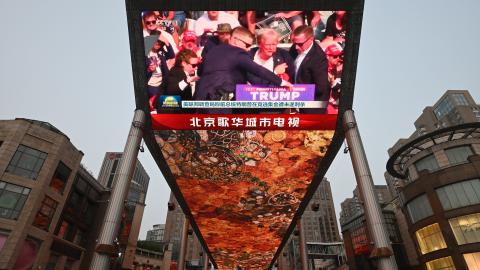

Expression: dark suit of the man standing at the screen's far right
xmin=290 ymin=42 xmax=330 ymax=113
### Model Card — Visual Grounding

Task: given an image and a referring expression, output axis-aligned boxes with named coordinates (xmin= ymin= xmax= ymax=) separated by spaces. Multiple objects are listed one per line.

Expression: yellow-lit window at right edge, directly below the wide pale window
xmin=448 ymin=214 xmax=480 ymax=245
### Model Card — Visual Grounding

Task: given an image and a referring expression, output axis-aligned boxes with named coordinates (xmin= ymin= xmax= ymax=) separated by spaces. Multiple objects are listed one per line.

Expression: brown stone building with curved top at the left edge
xmin=0 ymin=119 xmax=86 ymax=269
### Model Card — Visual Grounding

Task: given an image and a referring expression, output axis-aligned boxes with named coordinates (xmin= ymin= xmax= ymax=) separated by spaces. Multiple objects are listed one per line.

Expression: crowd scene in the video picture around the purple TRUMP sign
xmin=142 ymin=11 xmax=347 ymax=114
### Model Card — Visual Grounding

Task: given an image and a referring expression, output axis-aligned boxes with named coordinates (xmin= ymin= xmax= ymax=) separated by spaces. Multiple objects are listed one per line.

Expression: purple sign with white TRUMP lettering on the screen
xmin=235 ymin=84 xmax=315 ymax=101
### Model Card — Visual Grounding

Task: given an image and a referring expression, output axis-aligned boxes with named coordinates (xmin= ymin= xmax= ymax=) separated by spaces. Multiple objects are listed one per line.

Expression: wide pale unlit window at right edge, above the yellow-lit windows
xmin=436 ymin=179 xmax=480 ymax=210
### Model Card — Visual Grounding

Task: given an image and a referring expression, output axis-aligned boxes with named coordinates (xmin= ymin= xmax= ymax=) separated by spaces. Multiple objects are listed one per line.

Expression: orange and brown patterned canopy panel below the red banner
xmin=156 ymin=130 xmax=334 ymax=269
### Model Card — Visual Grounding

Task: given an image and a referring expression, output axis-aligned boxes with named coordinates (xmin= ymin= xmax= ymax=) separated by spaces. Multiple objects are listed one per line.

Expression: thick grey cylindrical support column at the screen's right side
xmin=343 ymin=110 xmax=397 ymax=270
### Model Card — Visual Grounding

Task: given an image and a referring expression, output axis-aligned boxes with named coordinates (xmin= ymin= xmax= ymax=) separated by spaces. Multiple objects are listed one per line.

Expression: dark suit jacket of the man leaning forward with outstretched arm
xmin=193 ymin=44 xmax=282 ymax=100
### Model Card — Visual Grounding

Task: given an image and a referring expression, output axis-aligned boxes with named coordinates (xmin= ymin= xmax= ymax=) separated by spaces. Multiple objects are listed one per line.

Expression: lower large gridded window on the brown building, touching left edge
xmin=0 ymin=182 xmax=30 ymax=219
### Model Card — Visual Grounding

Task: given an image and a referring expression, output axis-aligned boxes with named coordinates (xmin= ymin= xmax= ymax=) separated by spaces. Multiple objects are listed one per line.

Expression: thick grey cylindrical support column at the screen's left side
xmin=90 ymin=110 xmax=145 ymax=270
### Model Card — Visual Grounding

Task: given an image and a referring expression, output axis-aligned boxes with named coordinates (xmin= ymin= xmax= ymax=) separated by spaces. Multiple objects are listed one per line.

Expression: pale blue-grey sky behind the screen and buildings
xmin=0 ymin=0 xmax=480 ymax=239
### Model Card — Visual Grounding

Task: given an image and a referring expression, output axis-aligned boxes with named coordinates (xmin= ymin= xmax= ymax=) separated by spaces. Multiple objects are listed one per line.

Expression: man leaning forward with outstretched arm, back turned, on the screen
xmin=193 ymin=27 xmax=291 ymax=113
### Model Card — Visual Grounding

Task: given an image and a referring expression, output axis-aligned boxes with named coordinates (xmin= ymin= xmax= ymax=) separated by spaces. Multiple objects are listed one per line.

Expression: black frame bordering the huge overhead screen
xmin=125 ymin=0 xmax=364 ymax=268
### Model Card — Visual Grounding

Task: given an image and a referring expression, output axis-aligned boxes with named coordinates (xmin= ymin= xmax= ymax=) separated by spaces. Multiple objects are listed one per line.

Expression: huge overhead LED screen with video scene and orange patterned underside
xmin=127 ymin=1 xmax=361 ymax=269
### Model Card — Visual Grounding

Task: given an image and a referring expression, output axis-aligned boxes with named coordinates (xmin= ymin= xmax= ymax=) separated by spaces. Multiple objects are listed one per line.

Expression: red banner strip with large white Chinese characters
xmin=152 ymin=114 xmax=337 ymax=130
